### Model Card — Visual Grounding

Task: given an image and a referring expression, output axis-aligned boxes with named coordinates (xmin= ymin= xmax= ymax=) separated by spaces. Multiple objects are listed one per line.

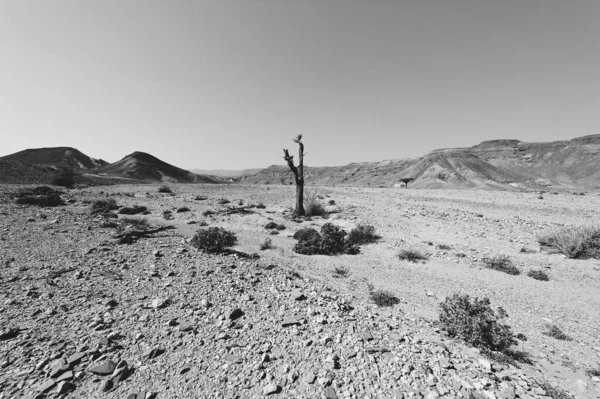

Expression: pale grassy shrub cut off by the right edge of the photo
xmin=538 ymin=226 xmax=600 ymax=259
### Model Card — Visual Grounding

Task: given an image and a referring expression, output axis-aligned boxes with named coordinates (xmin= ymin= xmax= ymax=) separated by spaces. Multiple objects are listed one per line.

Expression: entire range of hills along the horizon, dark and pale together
xmin=0 ymin=135 xmax=600 ymax=190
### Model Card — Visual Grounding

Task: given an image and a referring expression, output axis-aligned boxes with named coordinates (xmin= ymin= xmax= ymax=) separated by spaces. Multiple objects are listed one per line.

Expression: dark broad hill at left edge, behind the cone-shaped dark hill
xmin=0 ymin=147 xmax=107 ymax=170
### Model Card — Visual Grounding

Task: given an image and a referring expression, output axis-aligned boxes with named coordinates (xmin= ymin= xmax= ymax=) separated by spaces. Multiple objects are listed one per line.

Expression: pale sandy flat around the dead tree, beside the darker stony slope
xmin=2 ymin=184 xmax=600 ymax=397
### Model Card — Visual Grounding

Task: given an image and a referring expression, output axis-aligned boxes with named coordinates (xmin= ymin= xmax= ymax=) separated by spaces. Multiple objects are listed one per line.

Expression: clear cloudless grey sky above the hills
xmin=0 ymin=0 xmax=600 ymax=169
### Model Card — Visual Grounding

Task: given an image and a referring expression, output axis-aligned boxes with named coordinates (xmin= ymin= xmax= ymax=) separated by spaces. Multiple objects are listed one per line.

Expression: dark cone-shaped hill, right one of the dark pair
xmin=91 ymin=152 xmax=223 ymax=183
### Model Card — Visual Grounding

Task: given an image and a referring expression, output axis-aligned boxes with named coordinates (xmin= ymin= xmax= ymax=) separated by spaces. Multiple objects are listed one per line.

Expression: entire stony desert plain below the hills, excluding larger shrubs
xmin=0 ymin=141 xmax=600 ymax=399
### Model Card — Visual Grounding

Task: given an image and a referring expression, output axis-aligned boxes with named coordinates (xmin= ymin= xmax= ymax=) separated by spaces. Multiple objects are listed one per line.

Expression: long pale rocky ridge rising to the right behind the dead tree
xmin=240 ymin=135 xmax=600 ymax=189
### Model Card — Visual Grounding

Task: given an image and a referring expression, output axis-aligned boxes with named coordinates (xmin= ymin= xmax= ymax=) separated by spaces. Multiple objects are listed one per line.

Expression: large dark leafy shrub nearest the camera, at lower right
xmin=439 ymin=294 xmax=517 ymax=352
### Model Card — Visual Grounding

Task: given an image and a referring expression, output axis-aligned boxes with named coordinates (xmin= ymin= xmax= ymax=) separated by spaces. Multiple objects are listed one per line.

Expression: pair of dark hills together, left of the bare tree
xmin=0 ymin=147 xmax=225 ymax=183
